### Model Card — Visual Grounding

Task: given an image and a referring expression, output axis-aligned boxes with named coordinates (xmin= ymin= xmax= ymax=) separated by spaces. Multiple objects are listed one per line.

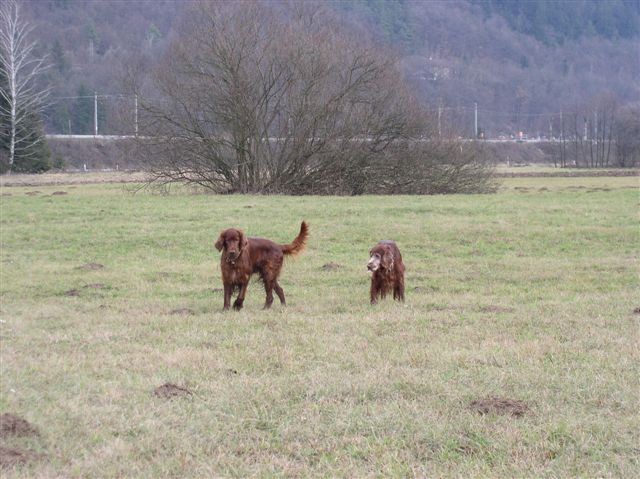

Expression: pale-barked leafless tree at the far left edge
xmin=0 ymin=0 xmax=49 ymax=172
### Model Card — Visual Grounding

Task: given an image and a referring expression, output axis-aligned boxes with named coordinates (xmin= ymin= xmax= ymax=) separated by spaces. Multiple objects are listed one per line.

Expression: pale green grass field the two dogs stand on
xmin=0 ymin=177 xmax=640 ymax=478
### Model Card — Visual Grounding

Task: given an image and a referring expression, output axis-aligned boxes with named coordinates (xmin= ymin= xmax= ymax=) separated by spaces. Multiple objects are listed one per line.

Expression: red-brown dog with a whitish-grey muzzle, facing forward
xmin=367 ymin=240 xmax=404 ymax=304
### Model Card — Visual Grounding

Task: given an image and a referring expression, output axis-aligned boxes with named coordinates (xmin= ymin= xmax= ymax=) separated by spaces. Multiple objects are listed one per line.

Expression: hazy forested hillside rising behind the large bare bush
xmin=17 ymin=0 xmax=640 ymax=136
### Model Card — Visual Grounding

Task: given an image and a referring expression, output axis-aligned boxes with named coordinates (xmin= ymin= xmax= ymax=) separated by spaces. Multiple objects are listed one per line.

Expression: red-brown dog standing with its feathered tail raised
xmin=215 ymin=221 xmax=309 ymax=310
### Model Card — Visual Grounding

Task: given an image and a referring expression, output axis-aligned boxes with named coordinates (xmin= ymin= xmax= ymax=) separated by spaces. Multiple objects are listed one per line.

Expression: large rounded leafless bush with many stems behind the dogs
xmin=129 ymin=2 xmax=492 ymax=194
